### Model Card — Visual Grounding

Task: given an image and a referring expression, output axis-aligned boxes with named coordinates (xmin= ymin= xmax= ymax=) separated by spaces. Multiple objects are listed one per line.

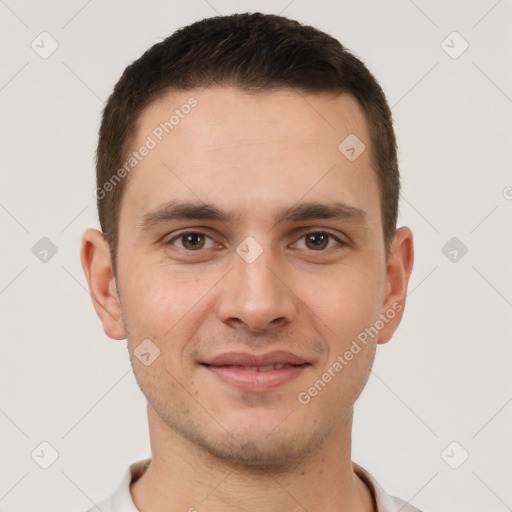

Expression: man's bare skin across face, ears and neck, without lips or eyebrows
xmin=81 ymin=88 xmax=413 ymax=512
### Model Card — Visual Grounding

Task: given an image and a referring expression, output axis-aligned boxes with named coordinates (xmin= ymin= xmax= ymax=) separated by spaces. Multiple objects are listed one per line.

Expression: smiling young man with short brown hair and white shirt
xmin=81 ymin=13 xmax=417 ymax=512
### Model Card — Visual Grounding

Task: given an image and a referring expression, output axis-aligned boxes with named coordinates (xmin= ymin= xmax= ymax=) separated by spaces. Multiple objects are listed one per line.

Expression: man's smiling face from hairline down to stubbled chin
xmin=82 ymin=88 xmax=412 ymax=464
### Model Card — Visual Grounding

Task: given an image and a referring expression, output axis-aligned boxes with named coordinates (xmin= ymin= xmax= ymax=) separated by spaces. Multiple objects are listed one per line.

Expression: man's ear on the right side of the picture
xmin=378 ymin=227 xmax=414 ymax=344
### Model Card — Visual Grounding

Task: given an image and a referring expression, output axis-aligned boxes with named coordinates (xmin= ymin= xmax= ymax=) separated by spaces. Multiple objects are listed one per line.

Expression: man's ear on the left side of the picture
xmin=80 ymin=229 xmax=126 ymax=340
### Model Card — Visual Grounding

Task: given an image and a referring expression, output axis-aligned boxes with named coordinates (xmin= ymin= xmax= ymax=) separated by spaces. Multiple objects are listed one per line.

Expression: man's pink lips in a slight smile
xmin=201 ymin=351 xmax=311 ymax=391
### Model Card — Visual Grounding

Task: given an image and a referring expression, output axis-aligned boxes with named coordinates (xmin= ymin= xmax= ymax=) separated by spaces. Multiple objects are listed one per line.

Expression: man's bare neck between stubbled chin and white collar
xmin=130 ymin=406 xmax=375 ymax=512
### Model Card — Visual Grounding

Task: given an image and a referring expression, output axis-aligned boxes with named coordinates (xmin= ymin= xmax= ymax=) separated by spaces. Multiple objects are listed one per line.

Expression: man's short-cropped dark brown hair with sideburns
xmin=96 ymin=13 xmax=400 ymax=271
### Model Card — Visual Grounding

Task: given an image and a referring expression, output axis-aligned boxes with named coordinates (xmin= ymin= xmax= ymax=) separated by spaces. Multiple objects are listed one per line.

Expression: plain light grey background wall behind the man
xmin=0 ymin=0 xmax=512 ymax=512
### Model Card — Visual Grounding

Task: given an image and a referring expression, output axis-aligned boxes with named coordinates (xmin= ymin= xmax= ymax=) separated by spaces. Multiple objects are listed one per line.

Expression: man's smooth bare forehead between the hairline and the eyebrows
xmin=122 ymin=87 xmax=380 ymax=232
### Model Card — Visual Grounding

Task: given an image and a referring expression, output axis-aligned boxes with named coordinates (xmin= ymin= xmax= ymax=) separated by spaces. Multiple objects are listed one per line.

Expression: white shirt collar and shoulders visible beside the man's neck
xmin=87 ymin=459 xmax=421 ymax=512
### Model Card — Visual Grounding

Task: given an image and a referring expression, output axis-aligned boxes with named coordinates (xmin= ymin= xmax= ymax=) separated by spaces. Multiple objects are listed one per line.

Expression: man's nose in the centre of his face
xmin=217 ymin=241 xmax=299 ymax=333
